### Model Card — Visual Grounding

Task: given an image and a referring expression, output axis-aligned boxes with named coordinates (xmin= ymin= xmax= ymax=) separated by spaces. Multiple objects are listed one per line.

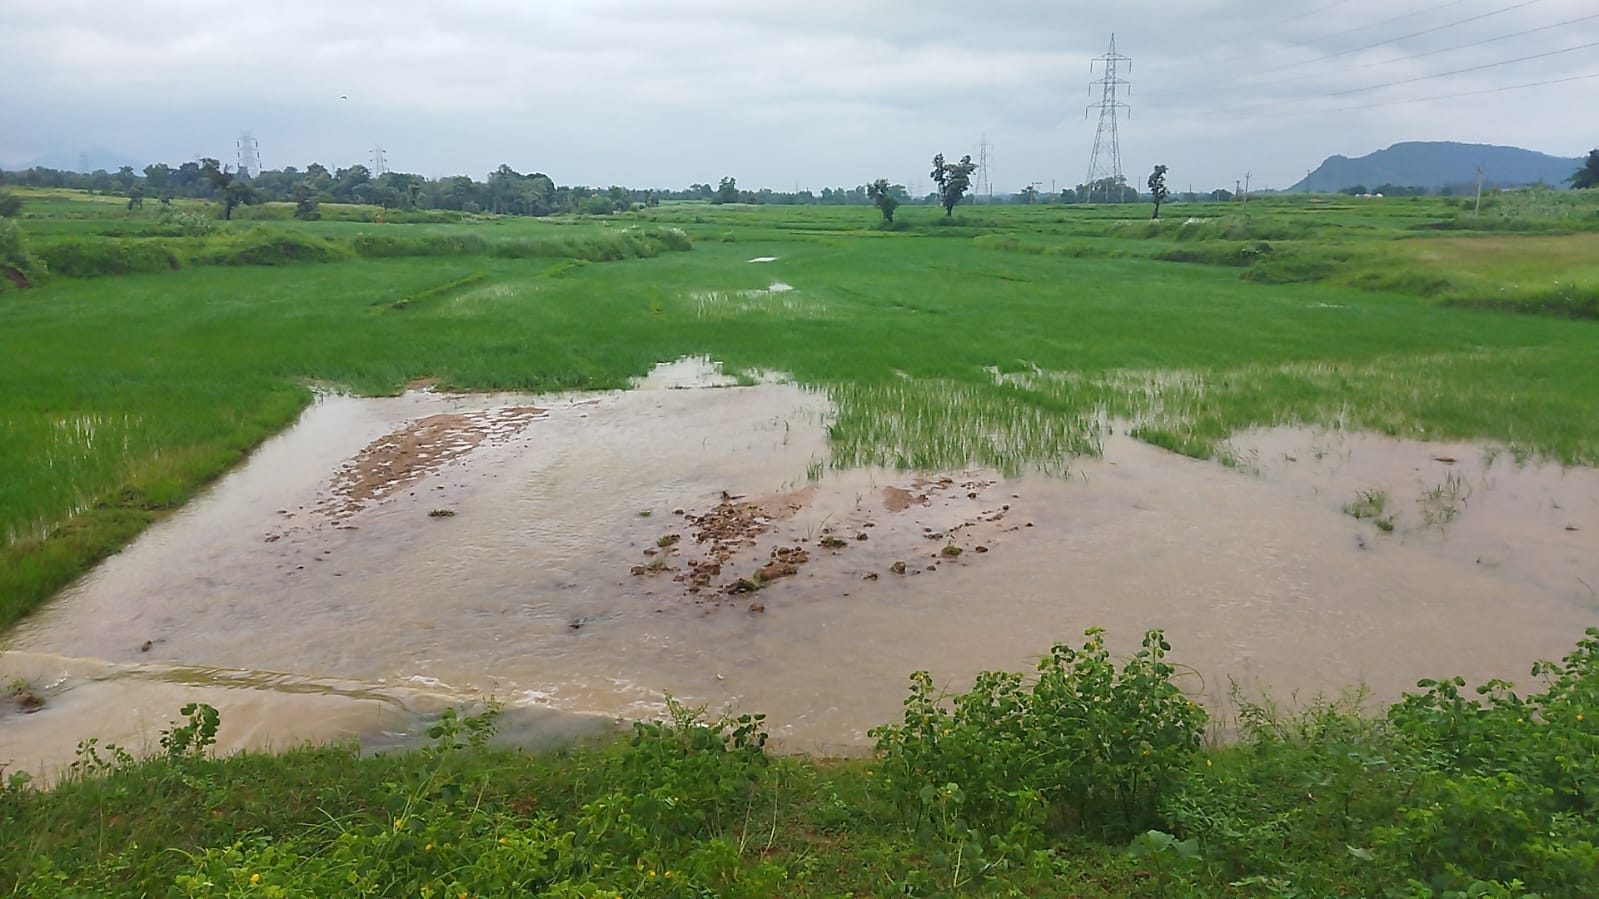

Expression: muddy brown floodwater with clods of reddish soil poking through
xmin=0 ymin=356 xmax=1599 ymax=771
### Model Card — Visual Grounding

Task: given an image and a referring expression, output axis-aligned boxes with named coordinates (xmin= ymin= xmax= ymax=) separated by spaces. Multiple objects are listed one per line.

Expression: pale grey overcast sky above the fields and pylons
xmin=0 ymin=0 xmax=1599 ymax=194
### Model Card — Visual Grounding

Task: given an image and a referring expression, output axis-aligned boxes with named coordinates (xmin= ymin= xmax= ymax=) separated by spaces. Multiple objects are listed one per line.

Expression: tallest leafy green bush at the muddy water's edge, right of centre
xmin=871 ymin=629 xmax=1206 ymax=845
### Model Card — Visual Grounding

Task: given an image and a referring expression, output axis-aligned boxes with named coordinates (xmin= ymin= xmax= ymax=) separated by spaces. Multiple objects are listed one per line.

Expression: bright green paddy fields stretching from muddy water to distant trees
xmin=0 ymin=192 xmax=1599 ymax=625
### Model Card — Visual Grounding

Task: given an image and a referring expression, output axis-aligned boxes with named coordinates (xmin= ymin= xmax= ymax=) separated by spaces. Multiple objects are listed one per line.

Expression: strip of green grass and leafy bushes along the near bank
xmin=0 ymin=629 xmax=1599 ymax=899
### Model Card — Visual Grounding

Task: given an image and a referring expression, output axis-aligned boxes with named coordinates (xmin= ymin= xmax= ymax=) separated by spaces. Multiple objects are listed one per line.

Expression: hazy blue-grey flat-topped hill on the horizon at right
xmin=1289 ymin=141 xmax=1583 ymax=194
